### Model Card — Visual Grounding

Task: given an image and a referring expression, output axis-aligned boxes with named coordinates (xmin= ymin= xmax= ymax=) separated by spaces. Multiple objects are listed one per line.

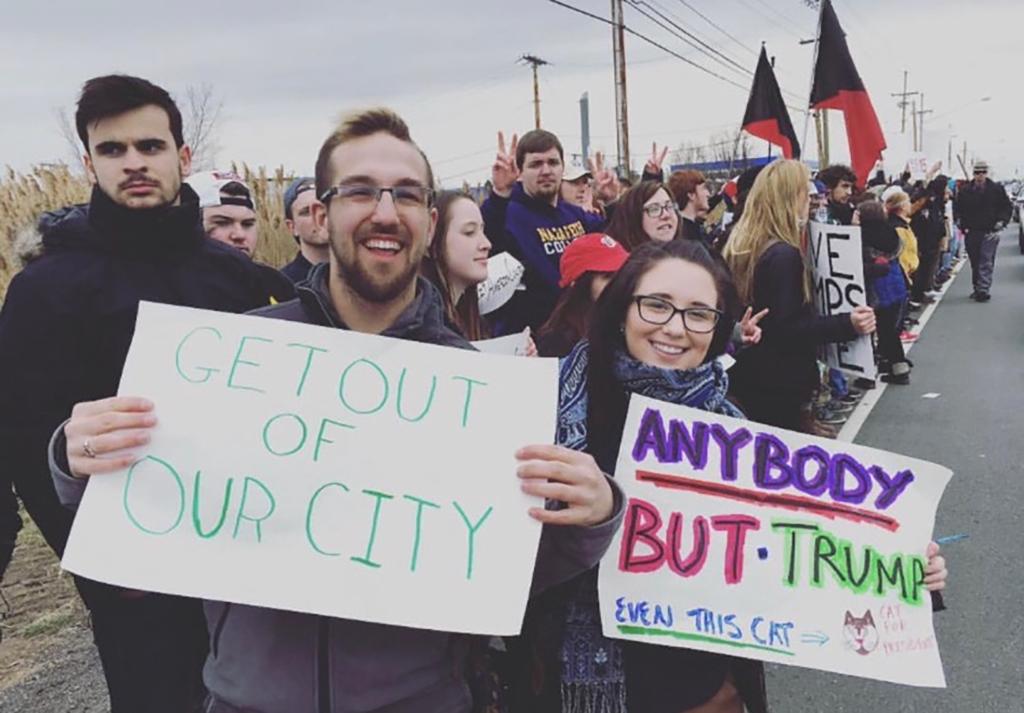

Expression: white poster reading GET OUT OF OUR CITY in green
xmin=63 ymin=303 xmax=557 ymax=634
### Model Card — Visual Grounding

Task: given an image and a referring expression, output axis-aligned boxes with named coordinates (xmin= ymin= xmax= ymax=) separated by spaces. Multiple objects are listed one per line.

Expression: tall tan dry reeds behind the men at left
xmin=0 ymin=164 xmax=297 ymax=300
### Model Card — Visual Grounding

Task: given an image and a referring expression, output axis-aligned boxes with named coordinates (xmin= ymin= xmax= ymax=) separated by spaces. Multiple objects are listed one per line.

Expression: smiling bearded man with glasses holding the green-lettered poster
xmin=51 ymin=110 xmax=624 ymax=713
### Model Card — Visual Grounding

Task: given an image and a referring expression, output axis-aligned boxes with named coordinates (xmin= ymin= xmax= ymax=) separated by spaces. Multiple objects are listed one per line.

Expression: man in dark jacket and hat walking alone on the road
xmin=956 ymin=161 xmax=1013 ymax=302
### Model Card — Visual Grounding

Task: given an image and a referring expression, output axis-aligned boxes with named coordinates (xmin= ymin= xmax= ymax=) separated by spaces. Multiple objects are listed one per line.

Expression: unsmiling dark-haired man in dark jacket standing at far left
xmin=0 ymin=76 xmax=280 ymax=713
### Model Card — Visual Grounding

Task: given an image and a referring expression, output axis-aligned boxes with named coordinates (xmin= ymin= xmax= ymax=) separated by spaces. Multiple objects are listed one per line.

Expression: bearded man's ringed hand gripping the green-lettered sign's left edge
xmin=65 ymin=396 xmax=157 ymax=477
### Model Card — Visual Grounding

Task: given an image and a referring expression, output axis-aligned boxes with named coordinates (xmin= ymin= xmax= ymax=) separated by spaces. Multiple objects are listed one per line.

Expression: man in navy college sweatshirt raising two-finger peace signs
xmin=481 ymin=129 xmax=618 ymax=333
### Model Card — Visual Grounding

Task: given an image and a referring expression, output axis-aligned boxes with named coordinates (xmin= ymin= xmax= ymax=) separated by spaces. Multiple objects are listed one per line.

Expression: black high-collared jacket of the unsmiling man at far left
xmin=0 ymin=185 xmax=280 ymax=573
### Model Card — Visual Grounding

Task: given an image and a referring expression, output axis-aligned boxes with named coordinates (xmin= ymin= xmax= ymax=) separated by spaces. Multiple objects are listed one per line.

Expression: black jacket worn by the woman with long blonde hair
xmin=729 ymin=243 xmax=857 ymax=401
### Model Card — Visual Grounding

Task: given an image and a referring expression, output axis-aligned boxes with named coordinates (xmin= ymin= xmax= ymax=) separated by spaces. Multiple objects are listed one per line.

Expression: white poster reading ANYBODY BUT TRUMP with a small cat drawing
xmin=599 ymin=395 xmax=951 ymax=686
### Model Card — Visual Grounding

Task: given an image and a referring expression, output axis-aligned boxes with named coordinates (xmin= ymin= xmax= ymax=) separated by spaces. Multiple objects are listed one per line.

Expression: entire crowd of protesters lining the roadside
xmin=0 ymin=76 xmax=983 ymax=713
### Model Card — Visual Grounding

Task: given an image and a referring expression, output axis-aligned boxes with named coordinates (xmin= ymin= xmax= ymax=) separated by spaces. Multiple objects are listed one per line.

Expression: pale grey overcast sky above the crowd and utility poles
xmin=0 ymin=0 xmax=1024 ymax=185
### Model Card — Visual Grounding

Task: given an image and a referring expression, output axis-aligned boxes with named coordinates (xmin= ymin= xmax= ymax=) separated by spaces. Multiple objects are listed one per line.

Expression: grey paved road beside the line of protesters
xmin=768 ymin=223 xmax=1024 ymax=713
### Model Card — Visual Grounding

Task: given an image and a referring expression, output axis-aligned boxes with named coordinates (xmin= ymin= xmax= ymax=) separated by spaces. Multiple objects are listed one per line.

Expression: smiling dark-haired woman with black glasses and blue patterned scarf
xmin=513 ymin=237 xmax=778 ymax=713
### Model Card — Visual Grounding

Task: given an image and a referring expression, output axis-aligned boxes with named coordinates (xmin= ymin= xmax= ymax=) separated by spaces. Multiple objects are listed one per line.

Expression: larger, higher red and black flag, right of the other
xmin=811 ymin=0 xmax=886 ymax=185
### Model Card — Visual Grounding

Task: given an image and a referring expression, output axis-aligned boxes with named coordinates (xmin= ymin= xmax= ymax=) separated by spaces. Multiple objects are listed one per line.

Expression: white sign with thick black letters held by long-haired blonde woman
xmin=810 ymin=222 xmax=878 ymax=379
